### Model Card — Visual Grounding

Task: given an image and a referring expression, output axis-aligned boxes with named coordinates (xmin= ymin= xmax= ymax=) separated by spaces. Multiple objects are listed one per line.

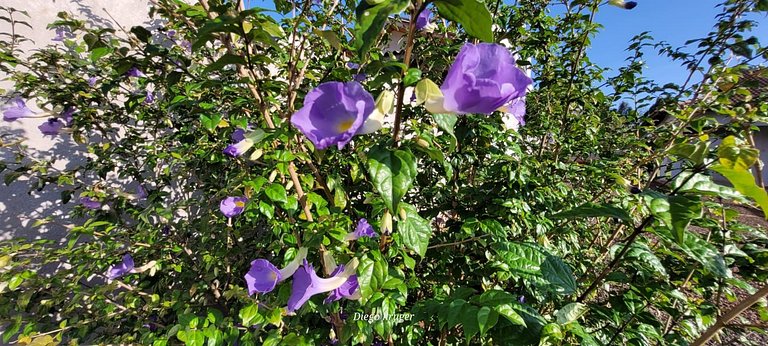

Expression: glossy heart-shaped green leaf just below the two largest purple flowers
xmin=368 ymin=147 xmax=418 ymax=215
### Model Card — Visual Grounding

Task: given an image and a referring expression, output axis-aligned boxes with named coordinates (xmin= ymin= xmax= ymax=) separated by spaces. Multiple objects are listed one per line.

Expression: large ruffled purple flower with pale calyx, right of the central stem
xmin=427 ymin=43 xmax=533 ymax=114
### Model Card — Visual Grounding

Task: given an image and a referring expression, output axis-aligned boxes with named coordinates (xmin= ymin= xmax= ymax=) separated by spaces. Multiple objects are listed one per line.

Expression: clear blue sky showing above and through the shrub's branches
xmin=245 ymin=0 xmax=768 ymax=85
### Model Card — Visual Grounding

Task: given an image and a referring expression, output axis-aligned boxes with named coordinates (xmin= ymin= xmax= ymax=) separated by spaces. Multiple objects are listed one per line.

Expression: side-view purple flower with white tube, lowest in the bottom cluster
xmin=287 ymin=258 xmax=358 ymax=312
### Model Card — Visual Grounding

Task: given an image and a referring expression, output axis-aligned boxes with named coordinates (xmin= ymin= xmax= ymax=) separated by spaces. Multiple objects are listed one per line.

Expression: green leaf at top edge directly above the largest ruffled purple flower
xmin=435 ymin=0 xmax=493 ymax=42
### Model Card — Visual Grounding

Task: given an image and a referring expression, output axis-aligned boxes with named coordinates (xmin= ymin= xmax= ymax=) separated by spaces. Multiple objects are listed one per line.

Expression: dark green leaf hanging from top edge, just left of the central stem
xmin=354 ymin=0 xmax=409 ymax=58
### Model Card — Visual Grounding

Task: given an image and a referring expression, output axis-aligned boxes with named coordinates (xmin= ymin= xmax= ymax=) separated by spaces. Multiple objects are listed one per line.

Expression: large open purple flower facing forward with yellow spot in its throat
xmin=291 ymin=82 xmax=374 ymax=149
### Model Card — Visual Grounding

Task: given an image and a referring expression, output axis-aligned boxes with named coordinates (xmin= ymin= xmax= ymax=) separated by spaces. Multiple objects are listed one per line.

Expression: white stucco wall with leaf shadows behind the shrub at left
xmin=0 ymin=0 xmax=157 ymax=240
